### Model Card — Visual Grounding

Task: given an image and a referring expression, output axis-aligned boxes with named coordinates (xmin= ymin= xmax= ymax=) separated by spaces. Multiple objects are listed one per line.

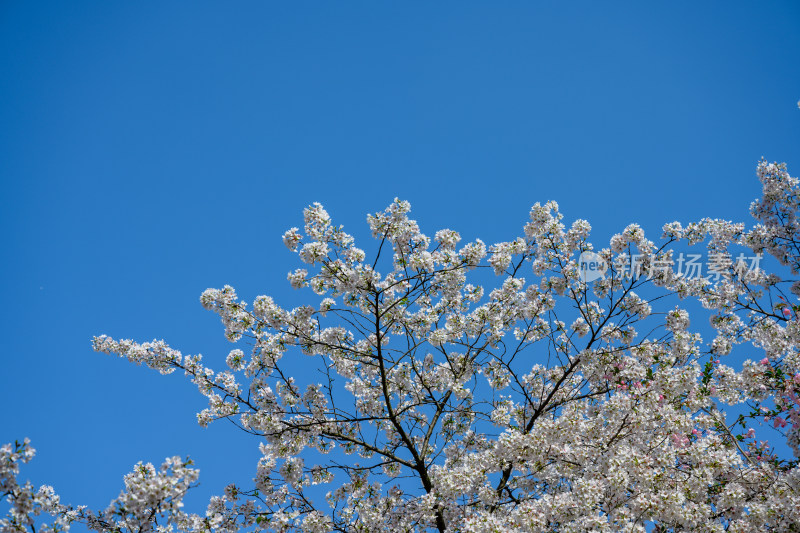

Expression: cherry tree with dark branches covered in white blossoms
xmin=6 ymin=160 xmax=800 ymax=532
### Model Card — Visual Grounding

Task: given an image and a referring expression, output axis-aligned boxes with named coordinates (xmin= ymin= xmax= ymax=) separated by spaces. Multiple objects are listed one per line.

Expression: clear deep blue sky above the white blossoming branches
xmin=0 ymin=1 xmax=800 ymax=520
